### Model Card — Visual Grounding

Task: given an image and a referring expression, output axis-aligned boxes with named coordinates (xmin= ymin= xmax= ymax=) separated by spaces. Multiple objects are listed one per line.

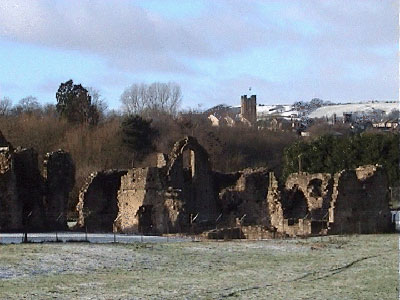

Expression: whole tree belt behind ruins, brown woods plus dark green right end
xmin=0 ymin=80 xmax=399 ymax=216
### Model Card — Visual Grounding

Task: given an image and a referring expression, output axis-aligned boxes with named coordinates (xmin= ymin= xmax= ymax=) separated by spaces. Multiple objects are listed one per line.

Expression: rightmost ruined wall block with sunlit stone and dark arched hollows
xmin=267 ymin=166 xmax=390 ymax=236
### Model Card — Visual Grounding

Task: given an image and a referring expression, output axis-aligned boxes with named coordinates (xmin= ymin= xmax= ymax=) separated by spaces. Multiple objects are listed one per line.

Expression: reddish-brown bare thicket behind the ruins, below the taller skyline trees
xmin=0 ymin=113 xmax=296 ymax=211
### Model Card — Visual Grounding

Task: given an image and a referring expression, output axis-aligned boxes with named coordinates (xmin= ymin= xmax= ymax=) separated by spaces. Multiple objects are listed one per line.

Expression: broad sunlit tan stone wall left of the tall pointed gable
xmin=114 ymin=167 xmax=167 ymax=233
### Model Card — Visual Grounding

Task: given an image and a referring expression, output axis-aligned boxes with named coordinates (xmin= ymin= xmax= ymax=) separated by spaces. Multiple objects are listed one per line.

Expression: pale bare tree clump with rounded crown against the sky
xmin=121 ymin=82 xmax=182 ymax=116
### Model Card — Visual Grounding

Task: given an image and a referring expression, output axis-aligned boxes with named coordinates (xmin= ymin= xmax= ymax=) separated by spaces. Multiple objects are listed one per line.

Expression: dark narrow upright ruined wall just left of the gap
xmin=43 ymin=150 xmax=75 ymax=230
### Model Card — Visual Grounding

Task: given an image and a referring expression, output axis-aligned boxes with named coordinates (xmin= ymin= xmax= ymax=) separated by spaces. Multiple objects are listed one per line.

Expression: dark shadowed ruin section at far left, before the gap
xmin=0 ymin=132 xmax=75 ymax=232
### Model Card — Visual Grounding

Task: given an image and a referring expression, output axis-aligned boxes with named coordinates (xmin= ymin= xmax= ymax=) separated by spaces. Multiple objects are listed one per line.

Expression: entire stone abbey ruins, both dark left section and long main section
xmin=0 ymin=134 xmax=392 ymax=238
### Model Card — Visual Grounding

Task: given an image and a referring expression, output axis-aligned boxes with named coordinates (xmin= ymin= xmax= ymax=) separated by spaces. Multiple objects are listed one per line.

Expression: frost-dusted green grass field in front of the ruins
xmin=0 ymin=234 xmax=398 ymax=300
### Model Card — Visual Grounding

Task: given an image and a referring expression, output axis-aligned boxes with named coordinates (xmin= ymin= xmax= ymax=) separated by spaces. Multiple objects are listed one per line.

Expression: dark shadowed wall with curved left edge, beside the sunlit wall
xmin=77 ymin=170 xmax=128 ymax=232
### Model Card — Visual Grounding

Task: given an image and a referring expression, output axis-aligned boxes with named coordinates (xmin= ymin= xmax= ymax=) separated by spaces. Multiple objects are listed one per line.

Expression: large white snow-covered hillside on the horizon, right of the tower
xmin=309 ymin=102 xmax=399 ymax=118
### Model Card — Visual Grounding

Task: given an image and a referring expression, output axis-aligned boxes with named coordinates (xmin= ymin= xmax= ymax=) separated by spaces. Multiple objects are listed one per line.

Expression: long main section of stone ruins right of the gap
xmin=73 ymin=133 xmax=390 ymax=237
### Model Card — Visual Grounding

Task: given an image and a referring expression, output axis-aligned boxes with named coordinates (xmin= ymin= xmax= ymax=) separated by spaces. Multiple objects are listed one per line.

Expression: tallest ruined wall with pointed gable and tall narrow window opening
xmin=167 ymin=136 xmax=218 ymax=225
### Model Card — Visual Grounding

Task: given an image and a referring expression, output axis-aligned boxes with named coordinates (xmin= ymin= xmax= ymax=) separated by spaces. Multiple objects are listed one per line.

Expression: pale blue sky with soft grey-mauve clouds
xmin=0 ymin=0 xmax=399 ymax=109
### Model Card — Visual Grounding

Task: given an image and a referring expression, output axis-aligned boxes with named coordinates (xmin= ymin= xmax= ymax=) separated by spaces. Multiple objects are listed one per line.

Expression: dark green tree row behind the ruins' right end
xmin=283 ymin=132 xmax=400 ymax=186
